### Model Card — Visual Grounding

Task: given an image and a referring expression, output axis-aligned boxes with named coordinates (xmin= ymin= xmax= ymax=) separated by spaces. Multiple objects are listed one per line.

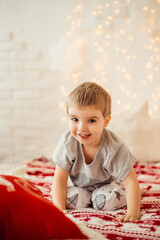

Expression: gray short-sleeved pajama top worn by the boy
xmin=52 ymin=129 xmax=135 ymax=189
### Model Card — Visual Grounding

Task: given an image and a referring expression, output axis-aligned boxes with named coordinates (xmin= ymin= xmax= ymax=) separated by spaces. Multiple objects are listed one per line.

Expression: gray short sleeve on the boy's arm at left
xmin=52 ymin=136 xmax=72 ymax=171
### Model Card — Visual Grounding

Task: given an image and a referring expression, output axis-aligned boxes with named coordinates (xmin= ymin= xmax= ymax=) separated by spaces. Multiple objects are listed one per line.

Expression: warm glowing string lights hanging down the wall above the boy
xmin=59 ymin=0 xmax=160 ymax=117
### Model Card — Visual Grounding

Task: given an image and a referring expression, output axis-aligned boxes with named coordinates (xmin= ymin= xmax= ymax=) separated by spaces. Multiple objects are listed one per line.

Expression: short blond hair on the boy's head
xmin=66 ymin=82 xmax=111 ymax=117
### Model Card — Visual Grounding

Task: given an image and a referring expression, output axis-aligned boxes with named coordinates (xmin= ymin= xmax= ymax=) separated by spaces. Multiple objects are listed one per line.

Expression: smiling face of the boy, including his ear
xmin=68 ymin=105 xmax=110 ymax=147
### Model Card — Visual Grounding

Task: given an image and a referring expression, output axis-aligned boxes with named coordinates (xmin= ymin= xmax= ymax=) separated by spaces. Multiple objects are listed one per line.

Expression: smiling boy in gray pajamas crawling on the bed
xmin=53 ymin=82 xmax=141 ymax=222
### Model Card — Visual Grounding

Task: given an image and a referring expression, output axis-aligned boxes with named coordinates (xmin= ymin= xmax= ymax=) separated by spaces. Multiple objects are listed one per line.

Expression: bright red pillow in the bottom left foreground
xmin=0 ymin=175 xmax=88 ymax=240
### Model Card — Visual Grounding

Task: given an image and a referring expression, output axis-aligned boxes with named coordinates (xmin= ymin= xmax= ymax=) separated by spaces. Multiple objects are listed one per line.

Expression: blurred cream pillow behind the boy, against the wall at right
xmin=110 ymin=102 xmax=160 ymax=162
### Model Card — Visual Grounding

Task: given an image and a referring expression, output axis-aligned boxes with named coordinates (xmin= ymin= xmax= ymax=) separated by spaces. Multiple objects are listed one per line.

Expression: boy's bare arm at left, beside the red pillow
xmin=52 ymin=166 xmax=68 ymax=211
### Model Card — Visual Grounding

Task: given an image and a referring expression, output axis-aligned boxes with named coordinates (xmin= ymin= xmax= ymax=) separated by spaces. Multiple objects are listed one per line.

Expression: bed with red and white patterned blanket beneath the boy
xmin=0 ymin=157 xmax=160 ymax=240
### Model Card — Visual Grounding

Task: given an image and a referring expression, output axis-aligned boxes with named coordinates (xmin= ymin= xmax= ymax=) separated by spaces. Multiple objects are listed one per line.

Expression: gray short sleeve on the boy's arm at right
xmin=107 ymin=144 xmax=136 ymax=181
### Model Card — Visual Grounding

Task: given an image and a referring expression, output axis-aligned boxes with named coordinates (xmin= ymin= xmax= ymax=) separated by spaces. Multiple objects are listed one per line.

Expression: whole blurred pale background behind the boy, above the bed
xmin=0 ymin=0 xmax=160 ymax=163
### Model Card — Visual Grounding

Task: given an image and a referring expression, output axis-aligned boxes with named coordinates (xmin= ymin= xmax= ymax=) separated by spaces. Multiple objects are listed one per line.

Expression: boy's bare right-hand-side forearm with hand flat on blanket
xmin=118 ymin=169 xmax=141 ymax=222
